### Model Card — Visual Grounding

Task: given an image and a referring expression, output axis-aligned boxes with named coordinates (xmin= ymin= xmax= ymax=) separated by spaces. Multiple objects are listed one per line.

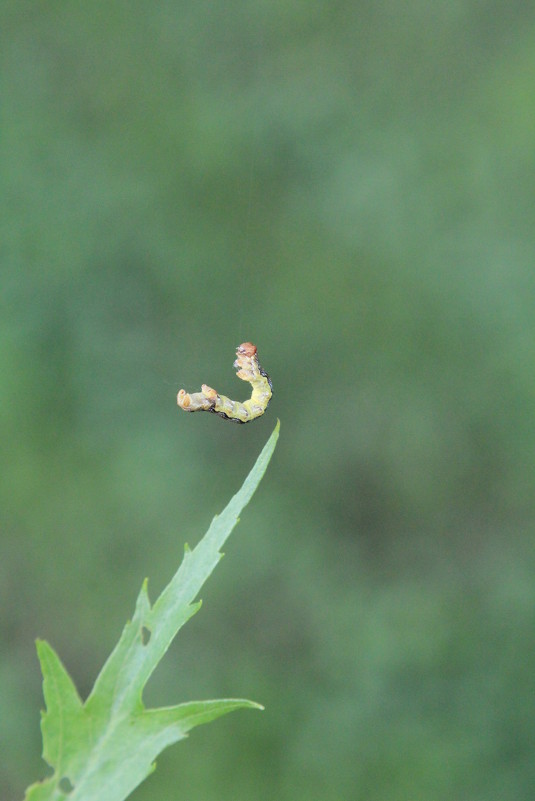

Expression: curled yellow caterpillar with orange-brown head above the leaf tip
xmin=176 ymin=342 xmax=273 ymax=423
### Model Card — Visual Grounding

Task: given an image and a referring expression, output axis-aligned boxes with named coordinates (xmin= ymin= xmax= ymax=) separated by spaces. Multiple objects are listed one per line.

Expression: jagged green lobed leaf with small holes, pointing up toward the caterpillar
xmin=25 ymin=423 xmax=279 ymax=801
